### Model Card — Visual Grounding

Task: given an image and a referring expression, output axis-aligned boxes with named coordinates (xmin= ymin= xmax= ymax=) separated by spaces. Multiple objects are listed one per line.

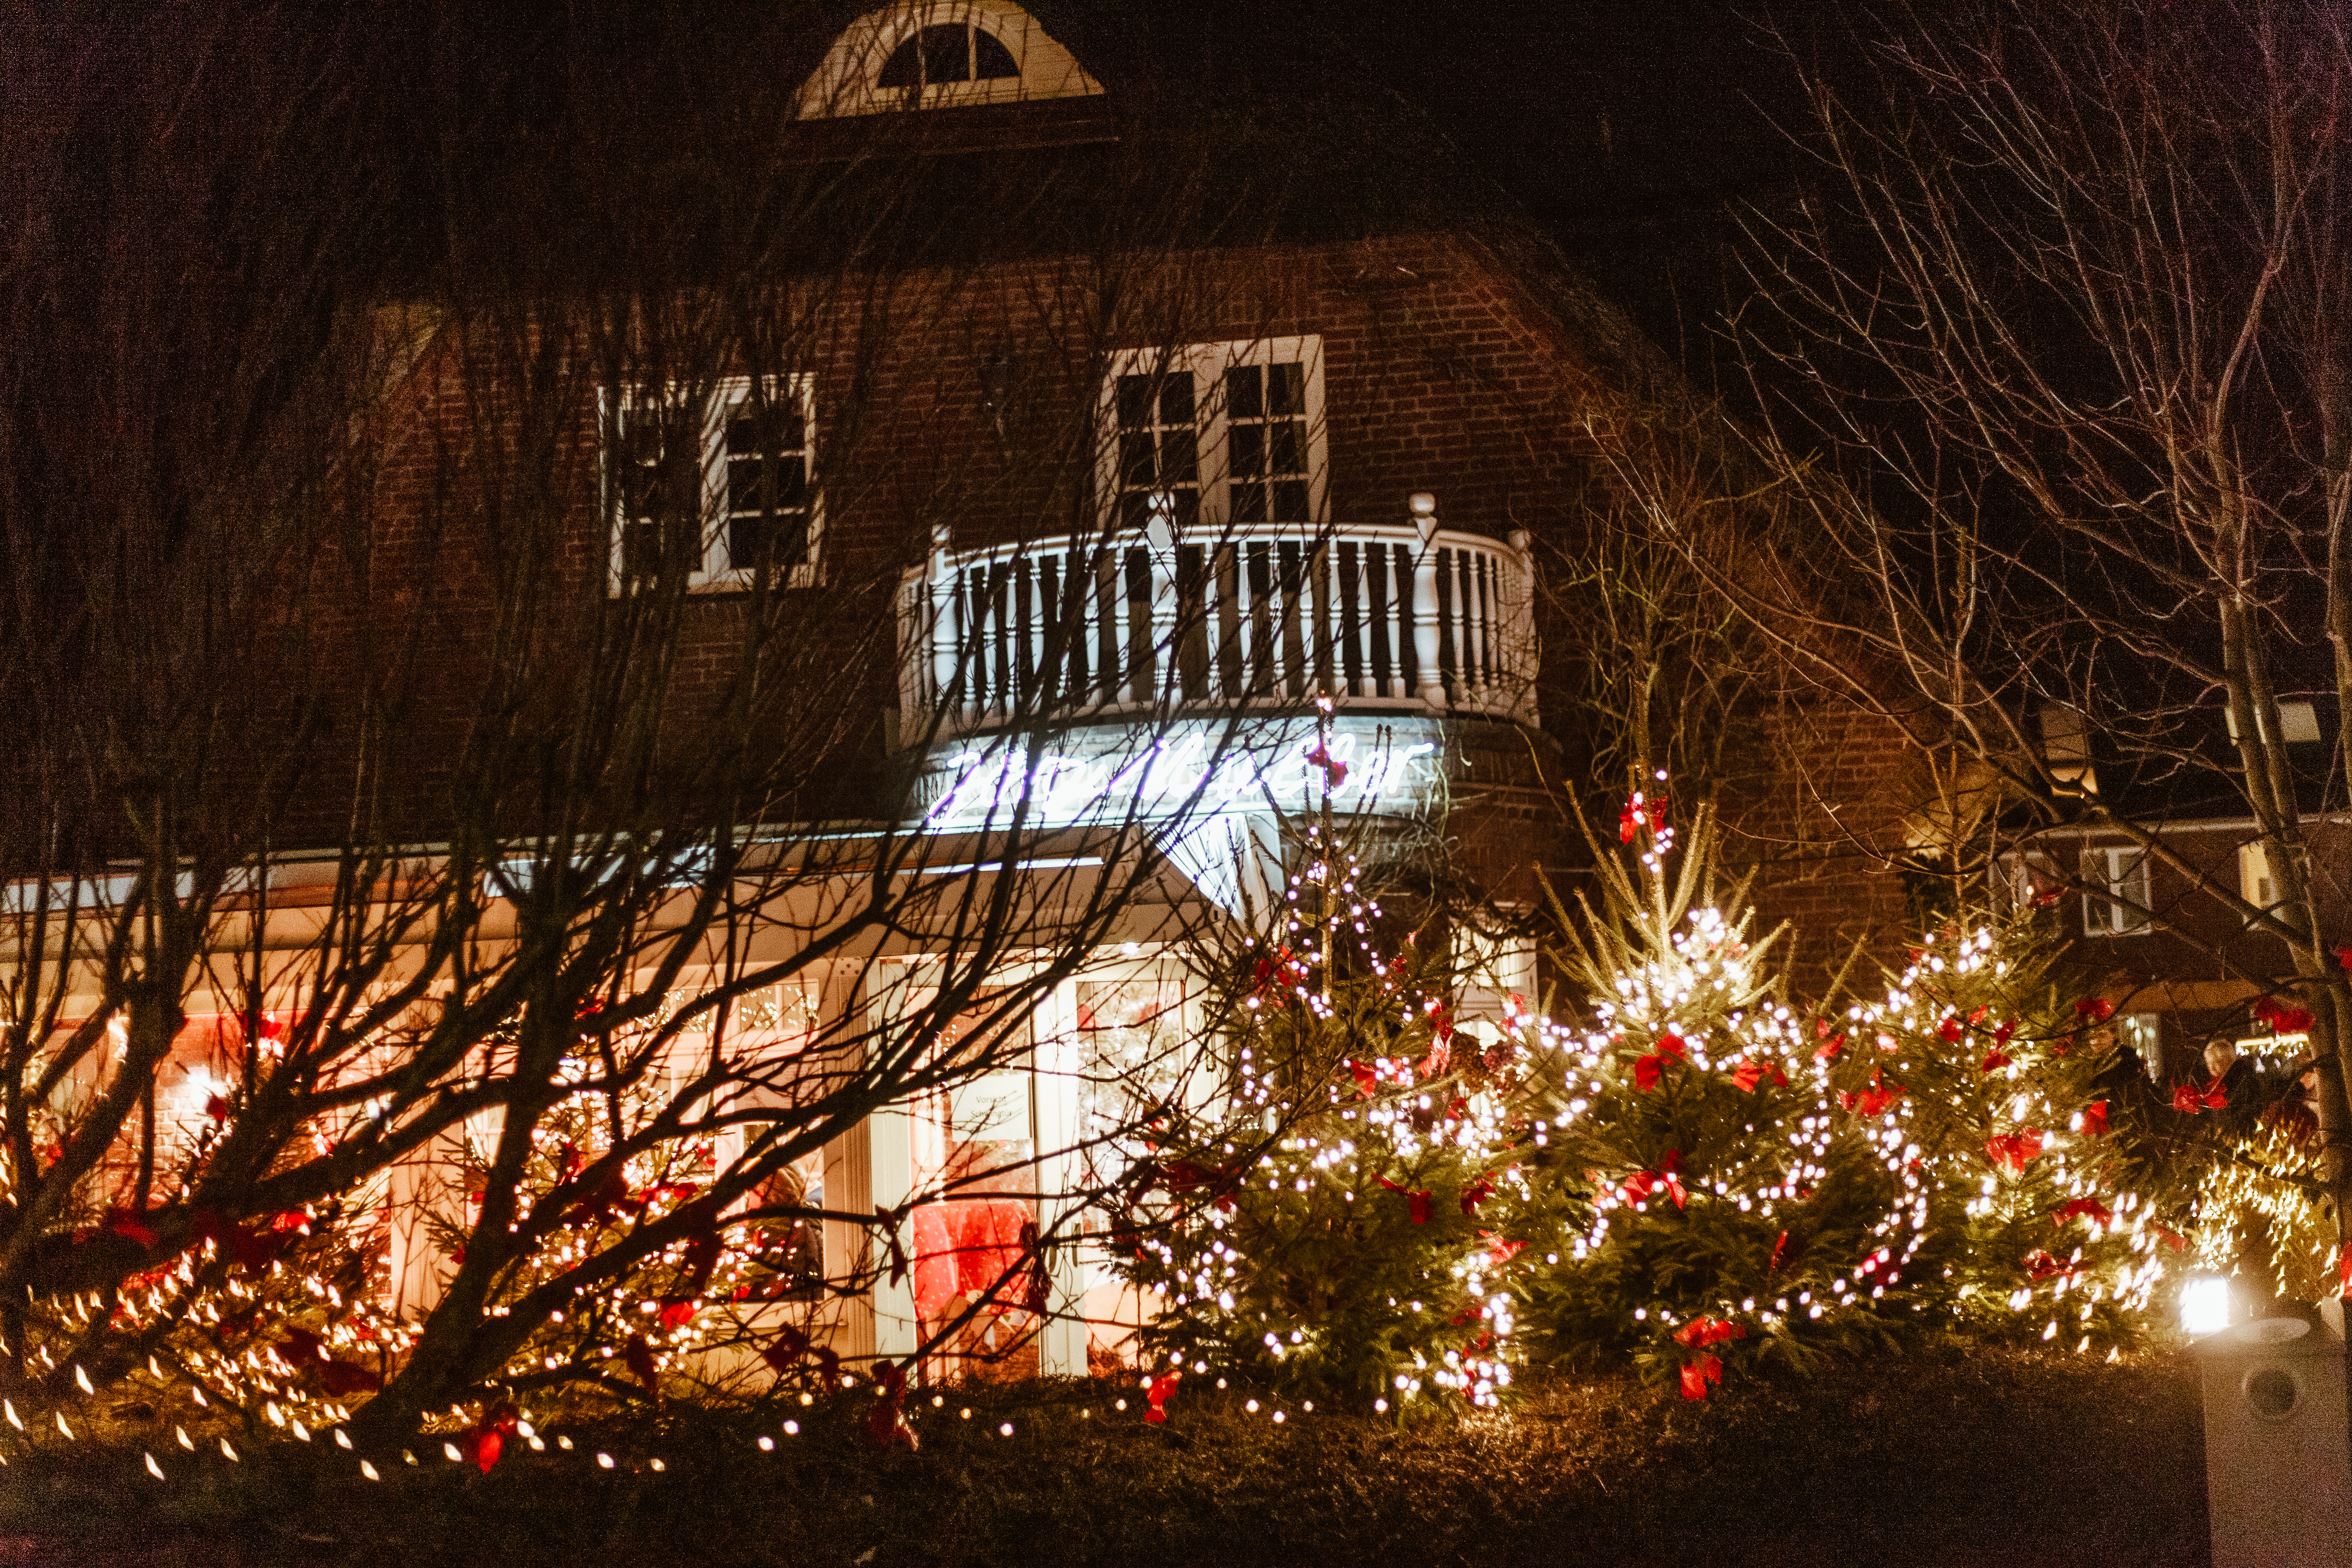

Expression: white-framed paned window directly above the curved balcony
xmin=1099 ymin=336 xmax=1331 ymax=538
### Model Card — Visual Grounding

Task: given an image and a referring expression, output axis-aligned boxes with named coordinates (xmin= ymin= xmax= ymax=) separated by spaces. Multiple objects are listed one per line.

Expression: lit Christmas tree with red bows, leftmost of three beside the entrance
xmin=1117 ymin=738 xmax=1557 ymax=1411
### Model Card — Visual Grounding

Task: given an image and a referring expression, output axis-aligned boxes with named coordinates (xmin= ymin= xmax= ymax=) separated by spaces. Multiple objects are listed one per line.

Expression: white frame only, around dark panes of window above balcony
xmin=1093 ymin=334 xmax=1331 ymax=538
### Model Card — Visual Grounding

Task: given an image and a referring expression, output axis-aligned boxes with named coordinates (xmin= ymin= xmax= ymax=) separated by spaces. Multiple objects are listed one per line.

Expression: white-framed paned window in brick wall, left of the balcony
xmin=597 ymin=376 xmax=823 ymax=593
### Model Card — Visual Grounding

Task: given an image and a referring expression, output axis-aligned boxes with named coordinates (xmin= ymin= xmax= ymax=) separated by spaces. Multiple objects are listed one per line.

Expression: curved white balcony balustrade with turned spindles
xmin=898 ymin=494 xmax=1536 ymax=743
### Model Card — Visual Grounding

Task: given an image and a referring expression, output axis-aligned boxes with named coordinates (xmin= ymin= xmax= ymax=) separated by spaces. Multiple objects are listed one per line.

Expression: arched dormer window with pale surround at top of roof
xmin=799 ymin=0 xmax=1103 ymax=120
